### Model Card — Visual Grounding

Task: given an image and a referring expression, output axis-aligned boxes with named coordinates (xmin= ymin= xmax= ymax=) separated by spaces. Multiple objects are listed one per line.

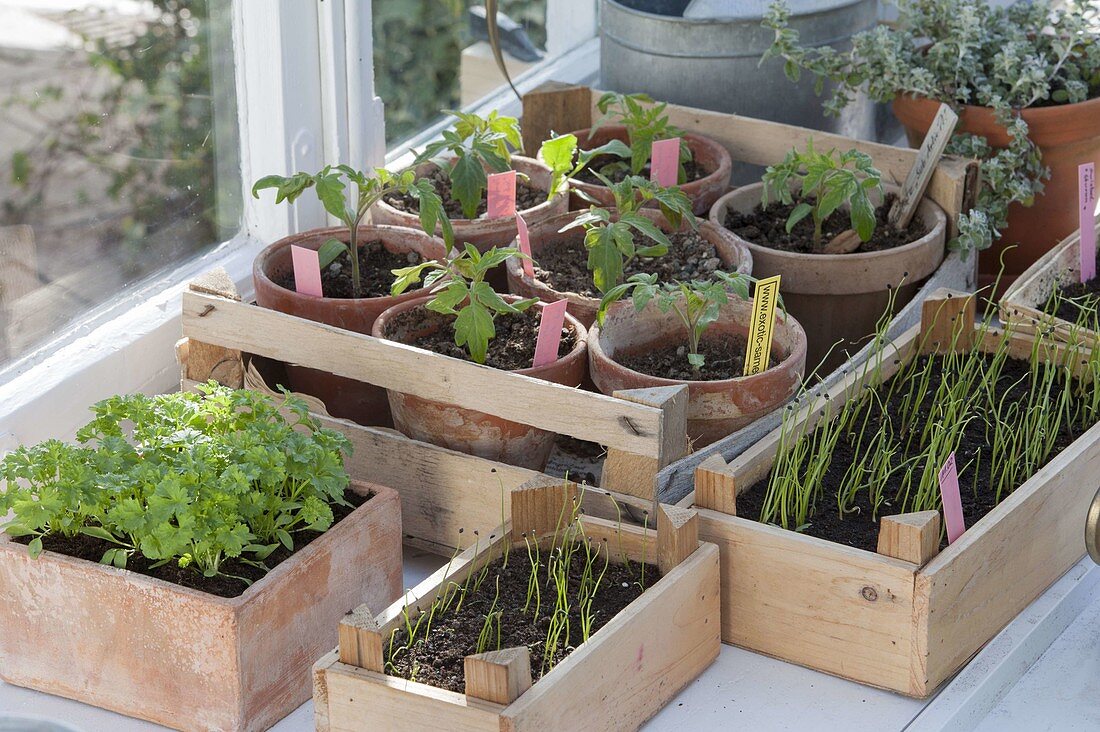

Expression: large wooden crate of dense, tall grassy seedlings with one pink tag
xmin=684 ymin=293 xmax=1100 ymax=697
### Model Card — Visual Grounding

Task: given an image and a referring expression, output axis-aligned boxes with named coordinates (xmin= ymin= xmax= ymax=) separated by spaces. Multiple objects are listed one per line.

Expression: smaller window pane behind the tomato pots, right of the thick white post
xmin=374 ymin=0 xmax=547 ymax=146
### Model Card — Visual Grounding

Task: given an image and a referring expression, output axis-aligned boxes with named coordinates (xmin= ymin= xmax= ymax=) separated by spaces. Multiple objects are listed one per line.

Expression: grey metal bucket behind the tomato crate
xmin=600 ymin=0 xmax=878 ymax=140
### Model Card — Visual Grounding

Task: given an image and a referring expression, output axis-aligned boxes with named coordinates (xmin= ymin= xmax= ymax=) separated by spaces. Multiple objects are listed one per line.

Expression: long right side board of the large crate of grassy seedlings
xmin=913 ymin=425 xmax=1100 ymax=692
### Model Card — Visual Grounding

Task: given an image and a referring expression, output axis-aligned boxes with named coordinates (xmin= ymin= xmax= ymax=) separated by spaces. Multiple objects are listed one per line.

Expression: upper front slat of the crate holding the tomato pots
xmin=183 ymin=292 xmax=660 ymax=459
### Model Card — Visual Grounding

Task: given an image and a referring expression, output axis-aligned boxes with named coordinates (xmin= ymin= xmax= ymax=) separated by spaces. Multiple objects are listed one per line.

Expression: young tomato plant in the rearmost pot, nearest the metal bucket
xmin=592 ymin=91 xmax=691 ymax=183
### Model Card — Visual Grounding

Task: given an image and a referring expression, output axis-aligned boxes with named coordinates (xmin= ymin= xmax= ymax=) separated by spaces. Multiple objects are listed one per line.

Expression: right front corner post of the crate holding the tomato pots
xmin=600 ymin=385 xmax=688 ymax=502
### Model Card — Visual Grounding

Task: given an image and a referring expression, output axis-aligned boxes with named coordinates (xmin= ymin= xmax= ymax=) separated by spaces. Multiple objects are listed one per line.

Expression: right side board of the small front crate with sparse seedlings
xmin=501 ymin=544 xmax=721 ymax=732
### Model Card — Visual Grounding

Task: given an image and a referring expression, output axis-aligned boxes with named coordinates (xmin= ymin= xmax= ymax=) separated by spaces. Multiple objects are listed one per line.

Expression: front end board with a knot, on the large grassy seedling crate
xmin=699 ymin=510 xmax=915 ymax=691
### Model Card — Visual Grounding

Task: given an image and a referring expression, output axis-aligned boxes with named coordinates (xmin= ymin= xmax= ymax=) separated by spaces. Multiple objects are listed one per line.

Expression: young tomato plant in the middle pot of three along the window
xmin=416 ymin=110 xmax=524 ymax=219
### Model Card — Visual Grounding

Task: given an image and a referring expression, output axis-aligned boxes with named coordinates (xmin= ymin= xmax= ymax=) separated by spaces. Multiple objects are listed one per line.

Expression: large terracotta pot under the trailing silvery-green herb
xmin=893 ymin=96 xmax=1100 ymax=297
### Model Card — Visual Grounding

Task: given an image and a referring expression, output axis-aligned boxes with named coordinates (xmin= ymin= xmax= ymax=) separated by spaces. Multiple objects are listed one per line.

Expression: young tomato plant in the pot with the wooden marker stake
xmin=762 ymin=138 xmax=882 ymax=245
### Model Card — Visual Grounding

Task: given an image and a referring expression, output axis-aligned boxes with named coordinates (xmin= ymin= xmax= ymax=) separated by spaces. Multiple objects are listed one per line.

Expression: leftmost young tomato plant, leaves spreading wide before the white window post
xmin=252 ymin=165 xmax=454 ymax=297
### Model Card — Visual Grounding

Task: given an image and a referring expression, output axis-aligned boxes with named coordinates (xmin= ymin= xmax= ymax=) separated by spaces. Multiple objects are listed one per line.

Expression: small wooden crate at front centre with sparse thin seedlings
xmin=314 ymin=480 xmax=721 ymax=732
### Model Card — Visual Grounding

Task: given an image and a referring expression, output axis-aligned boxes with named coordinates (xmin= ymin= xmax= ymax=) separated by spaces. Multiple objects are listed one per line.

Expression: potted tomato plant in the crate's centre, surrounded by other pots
xmin=506 ymin=176 xmax=752 ymax=326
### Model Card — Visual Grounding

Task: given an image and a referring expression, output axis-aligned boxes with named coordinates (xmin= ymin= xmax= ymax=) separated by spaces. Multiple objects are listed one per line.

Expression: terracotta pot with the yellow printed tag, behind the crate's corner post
xmin=589 ymin=297 xmax=806 ymax=449
